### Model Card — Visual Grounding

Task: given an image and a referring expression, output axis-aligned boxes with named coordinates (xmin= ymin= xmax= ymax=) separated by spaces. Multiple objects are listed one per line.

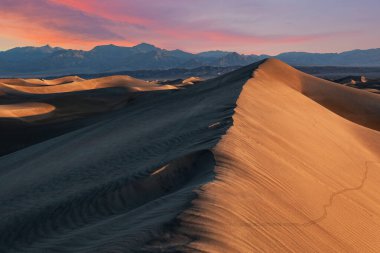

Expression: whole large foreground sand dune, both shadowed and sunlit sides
xmin=0 ymin=59 xmax=380 ymax=253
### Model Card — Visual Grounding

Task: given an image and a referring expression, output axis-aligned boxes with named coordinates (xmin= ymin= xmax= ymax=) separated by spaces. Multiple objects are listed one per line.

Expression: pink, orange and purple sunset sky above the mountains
xmin=0 ymin=0 xmax=380 ymax=54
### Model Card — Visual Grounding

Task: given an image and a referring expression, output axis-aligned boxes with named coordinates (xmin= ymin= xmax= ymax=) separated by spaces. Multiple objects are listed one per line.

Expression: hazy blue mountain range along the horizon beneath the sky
xmin=0 ymin=43 xmax=380 ymax=77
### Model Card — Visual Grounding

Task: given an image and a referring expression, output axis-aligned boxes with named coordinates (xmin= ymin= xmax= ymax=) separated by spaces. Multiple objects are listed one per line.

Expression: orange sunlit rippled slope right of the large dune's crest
xmin=180 ymin=60 xmax=380 ymax=252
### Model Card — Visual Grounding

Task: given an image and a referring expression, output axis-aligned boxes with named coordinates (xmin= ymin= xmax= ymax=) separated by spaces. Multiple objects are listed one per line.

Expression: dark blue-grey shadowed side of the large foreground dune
xmin=0 ymin=62 xmax=252 ymax=253
